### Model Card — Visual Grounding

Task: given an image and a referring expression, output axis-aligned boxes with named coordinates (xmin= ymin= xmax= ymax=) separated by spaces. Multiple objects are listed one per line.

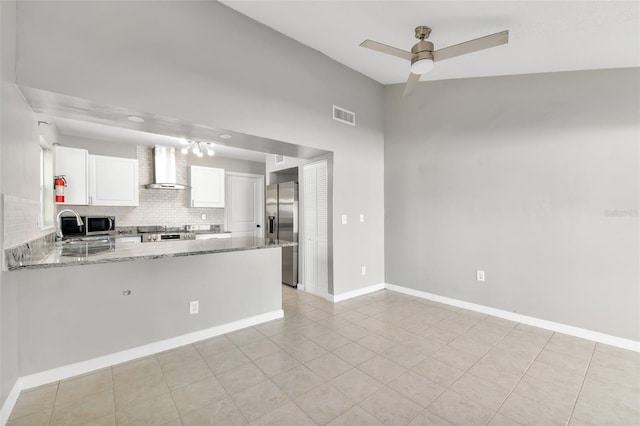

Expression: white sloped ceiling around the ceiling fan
xmin=222 ymin=0 xmax=640 ymax=84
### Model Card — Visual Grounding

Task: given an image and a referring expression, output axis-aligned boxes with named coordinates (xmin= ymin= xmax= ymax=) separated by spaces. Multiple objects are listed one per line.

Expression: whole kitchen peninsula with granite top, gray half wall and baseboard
xmin=8 ymin=237 xmax=293 ymax=380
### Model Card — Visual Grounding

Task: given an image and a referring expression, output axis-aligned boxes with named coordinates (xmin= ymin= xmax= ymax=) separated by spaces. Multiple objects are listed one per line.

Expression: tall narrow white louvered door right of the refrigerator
xmin=303 ymin=161 xmax=329 ymax=296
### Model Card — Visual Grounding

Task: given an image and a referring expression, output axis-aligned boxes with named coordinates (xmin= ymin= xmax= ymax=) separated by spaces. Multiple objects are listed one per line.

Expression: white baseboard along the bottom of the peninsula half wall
xmin=20 ymin=309 xmax=284 ymax=389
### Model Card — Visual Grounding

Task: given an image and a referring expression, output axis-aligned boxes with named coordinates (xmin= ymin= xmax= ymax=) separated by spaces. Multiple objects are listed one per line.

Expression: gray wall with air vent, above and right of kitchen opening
xmin=17 ymin=2 xmax=384 ymax=293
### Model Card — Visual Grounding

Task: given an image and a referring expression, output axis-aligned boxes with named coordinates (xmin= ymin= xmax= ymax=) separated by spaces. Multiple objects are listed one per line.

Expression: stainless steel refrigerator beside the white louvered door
xmin=266 ymin=182 xmax=298 ymax=287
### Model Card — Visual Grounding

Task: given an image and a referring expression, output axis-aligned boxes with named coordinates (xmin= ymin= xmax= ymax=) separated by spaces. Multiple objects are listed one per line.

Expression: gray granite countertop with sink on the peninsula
xmin=8 ymin=237 xmax=297 ymax=271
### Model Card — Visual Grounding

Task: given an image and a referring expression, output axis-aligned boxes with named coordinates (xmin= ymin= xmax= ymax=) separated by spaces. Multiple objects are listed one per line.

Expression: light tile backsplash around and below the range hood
xmin=58 ymin=146 xmax=224 ymax=226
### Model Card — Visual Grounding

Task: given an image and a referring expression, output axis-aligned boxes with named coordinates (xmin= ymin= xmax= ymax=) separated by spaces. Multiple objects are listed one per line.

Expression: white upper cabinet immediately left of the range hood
xmin=89 ymin=155 xmax=139 ymax=206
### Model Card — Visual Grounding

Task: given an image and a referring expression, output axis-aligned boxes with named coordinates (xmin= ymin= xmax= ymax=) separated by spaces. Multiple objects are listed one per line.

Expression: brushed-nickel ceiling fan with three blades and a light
xmin=360 ymin=25 xmax=509 ymax=97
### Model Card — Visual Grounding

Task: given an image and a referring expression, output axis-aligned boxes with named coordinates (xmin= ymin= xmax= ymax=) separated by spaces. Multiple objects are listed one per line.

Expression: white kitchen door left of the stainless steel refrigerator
xmin=224 ymin=172 xmax=264 ymax=237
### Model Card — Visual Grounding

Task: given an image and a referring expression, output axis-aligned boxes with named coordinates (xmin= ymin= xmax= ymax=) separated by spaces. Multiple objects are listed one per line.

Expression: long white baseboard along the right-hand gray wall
xmin=385 ymin=284 xmax=640 ymax=352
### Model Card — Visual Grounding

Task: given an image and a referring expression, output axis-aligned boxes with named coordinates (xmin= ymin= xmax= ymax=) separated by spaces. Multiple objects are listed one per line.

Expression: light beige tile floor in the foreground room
xmin=8 ymin=287 xmax=640 ymax=426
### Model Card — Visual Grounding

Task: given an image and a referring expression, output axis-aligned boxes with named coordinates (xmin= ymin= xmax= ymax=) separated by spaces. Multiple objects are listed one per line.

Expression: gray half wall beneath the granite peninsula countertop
xmin=14 ymin=248 xmax=282 ymax=376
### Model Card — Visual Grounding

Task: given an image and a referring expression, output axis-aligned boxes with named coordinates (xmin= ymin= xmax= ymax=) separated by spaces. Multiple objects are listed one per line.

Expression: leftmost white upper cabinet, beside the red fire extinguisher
xmin=51 ymin=146 xmax=89 ymax=206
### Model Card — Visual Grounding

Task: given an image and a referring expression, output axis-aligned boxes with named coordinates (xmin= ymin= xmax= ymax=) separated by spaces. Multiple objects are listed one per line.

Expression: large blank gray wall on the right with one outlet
xmin=385 ymin=69 xmax=640 ymax=341
